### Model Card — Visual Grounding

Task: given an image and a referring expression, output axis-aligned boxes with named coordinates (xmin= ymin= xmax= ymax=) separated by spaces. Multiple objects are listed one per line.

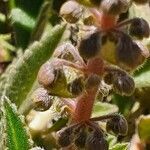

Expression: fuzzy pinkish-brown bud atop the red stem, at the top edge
xmin=101 ymin=0 xmax=130 ymax=15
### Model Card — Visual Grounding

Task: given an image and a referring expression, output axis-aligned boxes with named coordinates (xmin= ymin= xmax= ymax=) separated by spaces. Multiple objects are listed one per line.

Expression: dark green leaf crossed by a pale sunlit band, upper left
xmin=10 ymin=0 xmax=44 ymax=49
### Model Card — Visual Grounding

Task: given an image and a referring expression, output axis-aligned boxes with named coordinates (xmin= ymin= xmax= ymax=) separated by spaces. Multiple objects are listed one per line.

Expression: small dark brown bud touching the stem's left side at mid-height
xmin=68 ymin=77 xmax=84 ymax=96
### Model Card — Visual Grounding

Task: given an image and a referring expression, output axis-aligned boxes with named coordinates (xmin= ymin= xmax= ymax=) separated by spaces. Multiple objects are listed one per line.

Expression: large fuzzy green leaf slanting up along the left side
xmin=0 ymin=25 xmax=65 ymax=106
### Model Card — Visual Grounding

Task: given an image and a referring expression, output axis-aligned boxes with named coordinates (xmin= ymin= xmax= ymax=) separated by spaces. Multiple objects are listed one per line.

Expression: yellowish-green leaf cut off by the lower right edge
xmin=137 ymin=115 xmax=150 ymax=143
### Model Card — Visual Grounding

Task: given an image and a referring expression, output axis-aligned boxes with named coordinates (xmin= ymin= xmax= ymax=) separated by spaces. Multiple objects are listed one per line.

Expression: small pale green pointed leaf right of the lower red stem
xmin=92 ymin=102 xmax=118 ymax=117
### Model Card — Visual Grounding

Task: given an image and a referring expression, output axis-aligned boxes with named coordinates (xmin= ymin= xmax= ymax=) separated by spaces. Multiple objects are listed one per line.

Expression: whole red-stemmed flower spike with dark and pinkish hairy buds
xmin=31 ymin=0 xmax=150 ymax=150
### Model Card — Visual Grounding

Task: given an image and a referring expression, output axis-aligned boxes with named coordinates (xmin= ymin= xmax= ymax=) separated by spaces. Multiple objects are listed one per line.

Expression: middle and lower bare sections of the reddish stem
xmin=73 ymin=57 xmax=104 ymax=123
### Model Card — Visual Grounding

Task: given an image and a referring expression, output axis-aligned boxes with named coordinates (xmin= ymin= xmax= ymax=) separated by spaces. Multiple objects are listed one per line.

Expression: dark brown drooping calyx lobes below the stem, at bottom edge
xmin=58 ymin=123 xmax=108 ymax=150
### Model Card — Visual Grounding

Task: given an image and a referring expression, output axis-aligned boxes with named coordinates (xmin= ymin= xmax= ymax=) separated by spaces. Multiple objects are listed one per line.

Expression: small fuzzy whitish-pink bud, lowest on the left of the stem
xmin=32 ymin=88 xmax=52 ymax=111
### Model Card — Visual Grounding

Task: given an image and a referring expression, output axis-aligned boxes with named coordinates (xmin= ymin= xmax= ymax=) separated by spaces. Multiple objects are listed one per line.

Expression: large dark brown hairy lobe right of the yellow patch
xmin=116 ymin=31 xmax=145 ymax=70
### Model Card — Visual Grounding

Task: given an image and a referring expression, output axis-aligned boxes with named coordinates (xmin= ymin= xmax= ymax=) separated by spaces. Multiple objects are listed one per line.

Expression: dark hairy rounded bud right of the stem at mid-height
xmin=112 ymin=72 xmax=135 ymax=96
